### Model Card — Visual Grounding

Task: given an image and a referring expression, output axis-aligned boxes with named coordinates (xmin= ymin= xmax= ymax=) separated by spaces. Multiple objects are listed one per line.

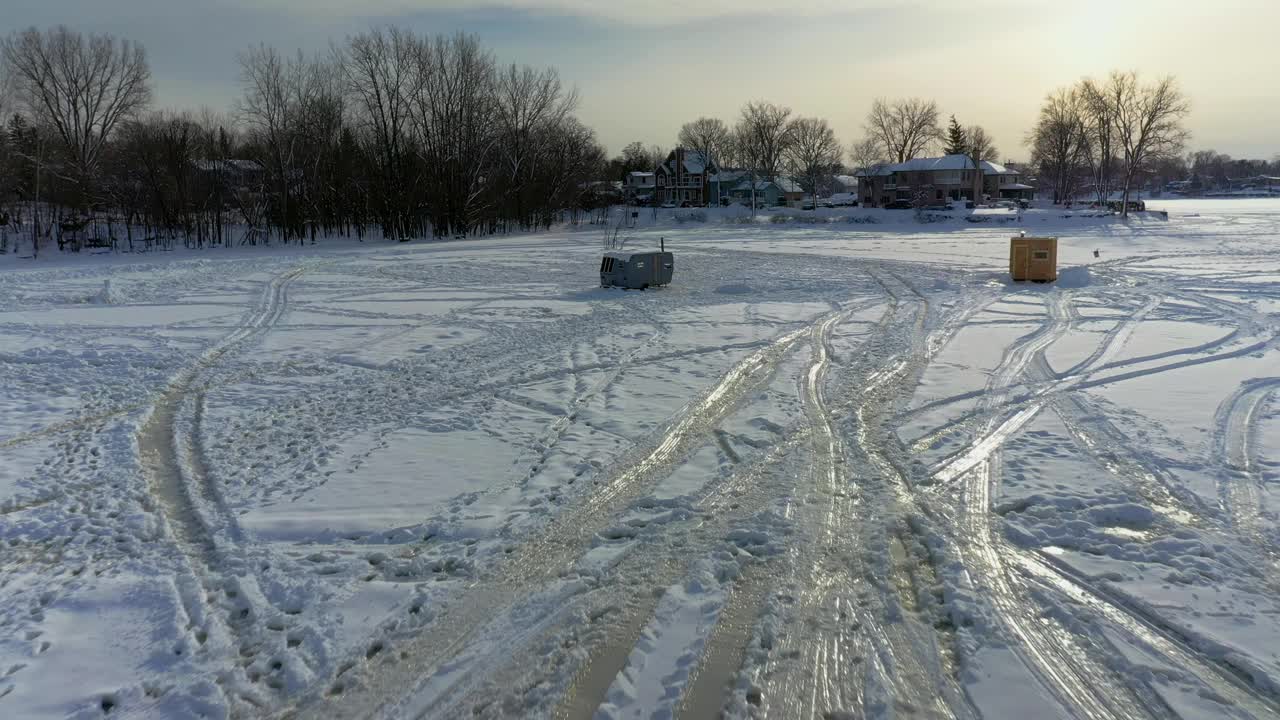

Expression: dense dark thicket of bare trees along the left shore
xmin=0 ymin=27 xmax=605 ymax=251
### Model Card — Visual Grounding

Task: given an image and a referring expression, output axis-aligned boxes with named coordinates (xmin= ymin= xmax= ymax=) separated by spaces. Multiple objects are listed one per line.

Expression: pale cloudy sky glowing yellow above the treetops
xmin=10 ymin=0 xmax=1280 ymax=159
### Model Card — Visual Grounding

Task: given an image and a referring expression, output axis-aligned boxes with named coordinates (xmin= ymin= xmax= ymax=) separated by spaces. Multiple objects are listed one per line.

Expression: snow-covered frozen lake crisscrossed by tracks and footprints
xmin=0 ymin=200 xmax=1280 ymax=719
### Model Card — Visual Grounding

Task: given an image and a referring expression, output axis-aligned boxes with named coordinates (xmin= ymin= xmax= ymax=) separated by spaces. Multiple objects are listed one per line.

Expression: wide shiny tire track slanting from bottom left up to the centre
xmin=286 ymin=310 xmax=826 ymax=717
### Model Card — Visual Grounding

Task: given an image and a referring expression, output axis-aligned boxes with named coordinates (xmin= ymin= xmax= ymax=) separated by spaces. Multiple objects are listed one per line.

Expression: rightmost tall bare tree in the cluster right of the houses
xmin=1107 ymin=72 xmax=1190 ymax=217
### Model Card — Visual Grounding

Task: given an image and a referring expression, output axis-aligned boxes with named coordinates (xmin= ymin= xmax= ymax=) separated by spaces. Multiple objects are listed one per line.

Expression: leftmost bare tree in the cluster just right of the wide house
xmin=1027 ymin=87 xmax=1089 ymax=204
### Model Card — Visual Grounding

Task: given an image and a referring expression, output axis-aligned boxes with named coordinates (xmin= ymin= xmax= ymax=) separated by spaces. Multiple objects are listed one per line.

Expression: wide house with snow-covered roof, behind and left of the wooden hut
xmin=858 ymin=155 xmax=1036 ymax=206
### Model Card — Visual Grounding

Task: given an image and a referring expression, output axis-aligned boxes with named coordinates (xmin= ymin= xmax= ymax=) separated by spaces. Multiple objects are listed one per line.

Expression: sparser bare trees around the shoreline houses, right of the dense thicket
xmin=609 ymin=72 xmax=1213 ymax=219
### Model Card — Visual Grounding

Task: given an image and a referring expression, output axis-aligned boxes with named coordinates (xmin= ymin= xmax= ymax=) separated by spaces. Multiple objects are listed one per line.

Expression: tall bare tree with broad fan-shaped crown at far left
xmin=0 ymin=26 xmax=151 ymax=185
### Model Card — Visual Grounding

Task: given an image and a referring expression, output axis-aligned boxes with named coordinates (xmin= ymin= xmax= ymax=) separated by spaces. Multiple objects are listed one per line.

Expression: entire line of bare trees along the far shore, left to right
xmin=0 ymin=27 xmax=1244 ymax=251
